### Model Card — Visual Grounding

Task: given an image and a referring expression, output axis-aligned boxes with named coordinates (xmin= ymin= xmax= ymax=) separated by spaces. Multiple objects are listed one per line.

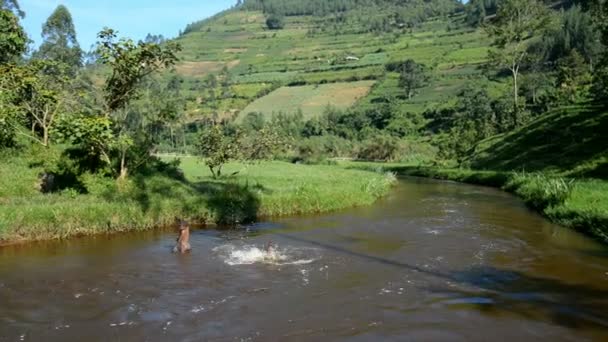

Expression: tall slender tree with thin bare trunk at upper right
xmin=487 ymin=0 xmax=549 ymax=116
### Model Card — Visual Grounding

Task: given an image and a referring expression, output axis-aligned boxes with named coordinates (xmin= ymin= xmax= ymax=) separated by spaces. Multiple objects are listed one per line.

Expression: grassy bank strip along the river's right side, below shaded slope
xmin=342 ymin=162 xmax=608 ymax=243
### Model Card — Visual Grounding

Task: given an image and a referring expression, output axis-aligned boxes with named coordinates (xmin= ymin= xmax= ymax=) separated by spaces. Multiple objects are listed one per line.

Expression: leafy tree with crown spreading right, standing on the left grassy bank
xmin=97 ymin=28 xmax=180 ymax=179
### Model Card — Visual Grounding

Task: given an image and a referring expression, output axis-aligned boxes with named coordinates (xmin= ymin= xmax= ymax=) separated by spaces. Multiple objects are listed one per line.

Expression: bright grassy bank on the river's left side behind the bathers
xmin=0 ymin=156 xmax=394 ymax=244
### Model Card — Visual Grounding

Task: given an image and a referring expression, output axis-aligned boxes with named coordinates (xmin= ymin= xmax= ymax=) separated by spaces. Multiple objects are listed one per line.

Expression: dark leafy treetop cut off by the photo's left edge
xmin=0 ymin=6 xmax=28 ymax=64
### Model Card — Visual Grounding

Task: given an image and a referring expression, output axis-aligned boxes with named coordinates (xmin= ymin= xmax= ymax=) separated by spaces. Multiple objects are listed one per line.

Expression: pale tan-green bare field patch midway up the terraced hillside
xmin=241 ymin=81 xmax=374 ymax=118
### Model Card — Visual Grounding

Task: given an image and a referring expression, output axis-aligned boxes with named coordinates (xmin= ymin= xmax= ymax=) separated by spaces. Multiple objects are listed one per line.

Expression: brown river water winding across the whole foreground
xmin=0 ymin=179 xmax=608 ymax=342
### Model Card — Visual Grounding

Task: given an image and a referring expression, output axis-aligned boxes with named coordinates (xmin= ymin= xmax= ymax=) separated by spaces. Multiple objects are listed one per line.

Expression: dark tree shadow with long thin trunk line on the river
xmin=275 ymin=233 xmax=608 ymax=330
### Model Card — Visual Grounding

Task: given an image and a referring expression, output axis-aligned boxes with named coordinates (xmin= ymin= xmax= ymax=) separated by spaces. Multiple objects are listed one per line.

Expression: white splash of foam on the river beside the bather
xmin=213 ymin=245 xmax=317 ymax=266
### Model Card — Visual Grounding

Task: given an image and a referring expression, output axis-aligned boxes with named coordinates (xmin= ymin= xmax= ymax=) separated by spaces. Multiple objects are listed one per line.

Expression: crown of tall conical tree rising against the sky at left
xmin=34 ymin=5 xmax=83 ymax=70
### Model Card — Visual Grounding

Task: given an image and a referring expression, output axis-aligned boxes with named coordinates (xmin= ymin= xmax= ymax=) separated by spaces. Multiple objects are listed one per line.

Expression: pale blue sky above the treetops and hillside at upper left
xmin=19 ymin=0 xmax=236 ymax=50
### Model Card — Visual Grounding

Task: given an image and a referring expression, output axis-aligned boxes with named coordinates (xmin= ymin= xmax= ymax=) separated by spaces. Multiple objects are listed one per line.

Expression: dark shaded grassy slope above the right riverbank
xmin=468 ymin=105 xmax=608 ymax=179
